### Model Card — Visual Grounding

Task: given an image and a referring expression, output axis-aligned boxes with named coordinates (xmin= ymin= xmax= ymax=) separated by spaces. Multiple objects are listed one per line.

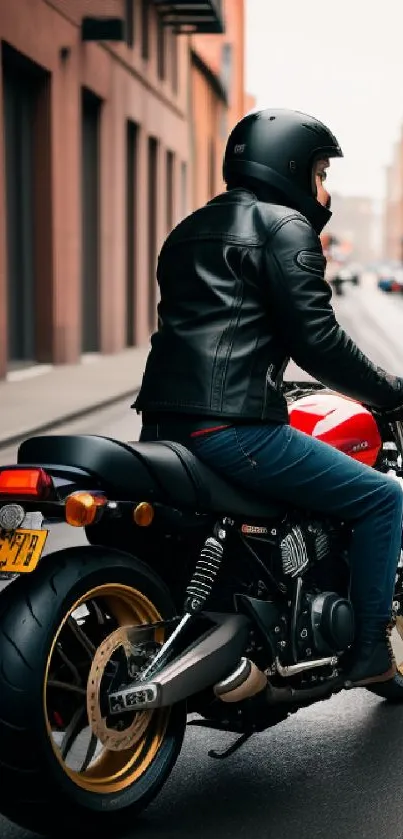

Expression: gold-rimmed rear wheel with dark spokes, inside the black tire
xmin=43 ymin=584 xmax=169 ymax=794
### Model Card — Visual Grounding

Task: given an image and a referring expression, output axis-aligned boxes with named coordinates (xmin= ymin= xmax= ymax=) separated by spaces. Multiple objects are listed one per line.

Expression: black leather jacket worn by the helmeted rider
xmin=133 ymin=189 xmax=403 ymax=422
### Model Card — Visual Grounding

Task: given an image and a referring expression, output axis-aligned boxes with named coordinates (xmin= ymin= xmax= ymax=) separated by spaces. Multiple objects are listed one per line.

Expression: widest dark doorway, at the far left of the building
xmin=2 ymin=43 xmax=50 ymax=367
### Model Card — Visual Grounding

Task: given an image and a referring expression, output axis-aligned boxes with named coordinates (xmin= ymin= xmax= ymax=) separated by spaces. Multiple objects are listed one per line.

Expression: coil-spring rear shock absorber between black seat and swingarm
xmin=185 ymin=519 xmax=229 ymax=615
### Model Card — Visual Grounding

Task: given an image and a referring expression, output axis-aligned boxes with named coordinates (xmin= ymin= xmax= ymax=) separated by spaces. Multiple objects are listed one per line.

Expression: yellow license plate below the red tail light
xmin=0 ymin=530 xmax=48 ymax=574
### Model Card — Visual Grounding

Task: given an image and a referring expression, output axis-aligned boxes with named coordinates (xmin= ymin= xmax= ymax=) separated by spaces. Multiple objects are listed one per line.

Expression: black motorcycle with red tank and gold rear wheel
xmin=0 ymin=382 xmax=403 ymax=836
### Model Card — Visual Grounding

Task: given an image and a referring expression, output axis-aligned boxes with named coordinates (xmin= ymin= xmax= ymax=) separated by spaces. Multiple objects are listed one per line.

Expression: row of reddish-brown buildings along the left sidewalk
xmin=0 ymin=0 xmax=251 ymax=377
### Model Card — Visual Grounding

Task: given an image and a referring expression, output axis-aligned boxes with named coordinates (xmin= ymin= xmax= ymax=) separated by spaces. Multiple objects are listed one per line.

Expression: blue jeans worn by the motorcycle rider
xmin=141 ymin=423 xmax=403 ymax=640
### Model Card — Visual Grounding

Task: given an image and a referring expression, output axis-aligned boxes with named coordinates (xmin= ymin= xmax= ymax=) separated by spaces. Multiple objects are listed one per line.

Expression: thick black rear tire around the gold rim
xmin=0 ymin=547 xmax=186 ymax=836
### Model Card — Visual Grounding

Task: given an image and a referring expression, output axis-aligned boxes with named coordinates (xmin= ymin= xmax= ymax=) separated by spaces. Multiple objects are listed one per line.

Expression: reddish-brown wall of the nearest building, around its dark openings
xmin=0 ymin=0 xmax=189 ymax=375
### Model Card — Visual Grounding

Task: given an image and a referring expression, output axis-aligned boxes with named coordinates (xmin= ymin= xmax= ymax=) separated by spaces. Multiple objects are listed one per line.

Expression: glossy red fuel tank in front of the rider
xmin=288 ymin=392 xmax=382 ymax=466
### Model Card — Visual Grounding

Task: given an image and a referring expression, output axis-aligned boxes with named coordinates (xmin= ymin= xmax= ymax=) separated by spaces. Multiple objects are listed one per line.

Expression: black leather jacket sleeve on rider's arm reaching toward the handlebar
xmin=264 ymin=215 xmax=403 ymax=409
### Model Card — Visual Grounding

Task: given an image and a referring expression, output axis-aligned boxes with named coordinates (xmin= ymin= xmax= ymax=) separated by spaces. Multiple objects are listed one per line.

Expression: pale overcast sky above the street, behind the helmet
xmin=245 ymin=0 xmax=403 ymax=198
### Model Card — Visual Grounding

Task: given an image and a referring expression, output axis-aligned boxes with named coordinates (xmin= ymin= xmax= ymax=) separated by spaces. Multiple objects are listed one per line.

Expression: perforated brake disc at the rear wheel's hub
xmin=87 ymin=626 xmax=153 ymax=752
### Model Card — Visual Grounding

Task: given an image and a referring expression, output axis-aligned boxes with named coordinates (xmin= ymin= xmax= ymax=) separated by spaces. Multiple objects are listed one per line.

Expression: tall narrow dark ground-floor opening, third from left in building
xmin=126 ymin=120 xmax=138 ymax=347
